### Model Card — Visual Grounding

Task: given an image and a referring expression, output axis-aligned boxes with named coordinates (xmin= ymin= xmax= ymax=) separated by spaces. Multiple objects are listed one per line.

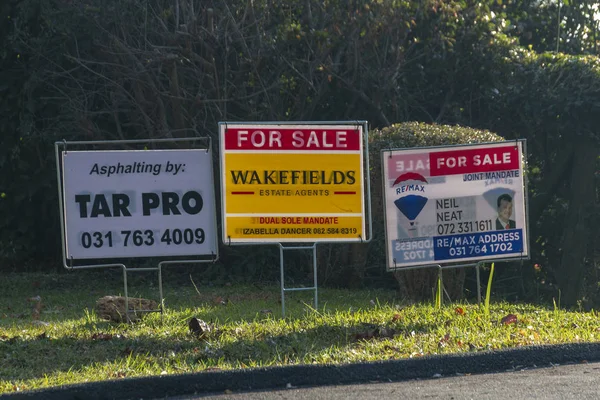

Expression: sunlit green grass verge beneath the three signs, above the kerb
xmin=0 ymin=271 xmax=600 ymax=394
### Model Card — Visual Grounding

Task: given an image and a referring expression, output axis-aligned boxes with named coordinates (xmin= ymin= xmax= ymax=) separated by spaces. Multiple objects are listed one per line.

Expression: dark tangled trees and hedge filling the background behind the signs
xmin=0 ymin=0 xmax=600 ymax=304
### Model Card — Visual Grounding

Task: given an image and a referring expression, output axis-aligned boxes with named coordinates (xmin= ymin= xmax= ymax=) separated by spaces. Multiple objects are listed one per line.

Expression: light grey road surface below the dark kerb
xmin=176 ymin=363 xmax=600 ymax=400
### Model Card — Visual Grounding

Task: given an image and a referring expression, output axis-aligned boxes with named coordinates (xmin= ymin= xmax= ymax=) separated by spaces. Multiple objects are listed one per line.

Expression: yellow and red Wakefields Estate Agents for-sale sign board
xmin=220 ymin=123 xmax=365 ymax=243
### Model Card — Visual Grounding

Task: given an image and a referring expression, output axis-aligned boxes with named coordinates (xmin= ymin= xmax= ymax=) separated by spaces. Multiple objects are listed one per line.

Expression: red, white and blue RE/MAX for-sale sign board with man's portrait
xmin=382 ymin=141 xmax=528 ymax=270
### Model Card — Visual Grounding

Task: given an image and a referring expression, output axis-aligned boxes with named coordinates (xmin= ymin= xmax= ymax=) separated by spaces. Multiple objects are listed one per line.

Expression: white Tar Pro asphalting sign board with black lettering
xmin=62 ymin=149 xmax=217 ymax=259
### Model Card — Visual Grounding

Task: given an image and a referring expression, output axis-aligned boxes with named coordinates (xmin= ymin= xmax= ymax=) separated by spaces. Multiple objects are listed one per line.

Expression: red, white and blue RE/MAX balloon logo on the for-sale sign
xmin=392 ymin=172 xmax=428 ymax=227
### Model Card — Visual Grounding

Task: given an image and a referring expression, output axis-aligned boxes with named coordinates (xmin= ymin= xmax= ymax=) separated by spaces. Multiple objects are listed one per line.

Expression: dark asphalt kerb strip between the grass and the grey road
xmin=0 ymin=343 xmax=600 ymax=400
